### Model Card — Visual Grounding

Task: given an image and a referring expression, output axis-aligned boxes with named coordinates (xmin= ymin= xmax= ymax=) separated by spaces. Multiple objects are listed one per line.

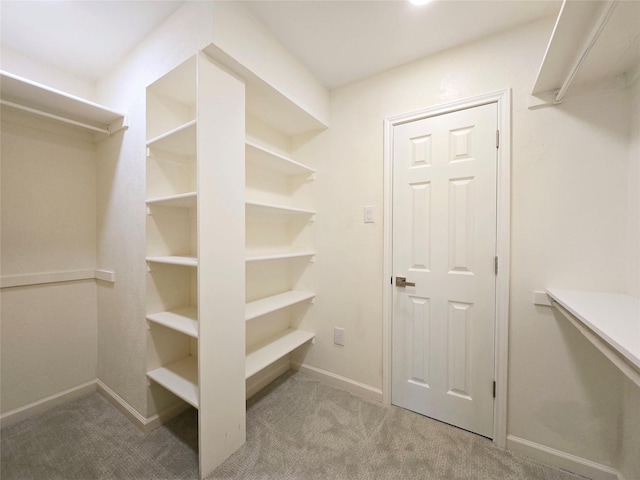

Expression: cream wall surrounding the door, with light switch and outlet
xmin=297 ymin=16 xmax=637 ymax=474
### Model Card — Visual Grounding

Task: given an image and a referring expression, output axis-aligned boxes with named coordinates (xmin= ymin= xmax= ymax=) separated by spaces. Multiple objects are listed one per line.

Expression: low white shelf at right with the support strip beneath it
xmin=546 ymin=288 xmax=640 ymax=387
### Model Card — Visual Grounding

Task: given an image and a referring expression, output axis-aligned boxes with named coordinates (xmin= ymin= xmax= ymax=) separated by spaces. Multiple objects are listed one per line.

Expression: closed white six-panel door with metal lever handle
xmin=391 ymin=103 xmax=497 ymax=437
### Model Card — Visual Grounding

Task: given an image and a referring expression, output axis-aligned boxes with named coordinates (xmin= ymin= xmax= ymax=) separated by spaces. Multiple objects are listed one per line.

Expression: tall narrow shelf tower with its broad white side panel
xmin=146 ymin=53 xmax=246 ymax=478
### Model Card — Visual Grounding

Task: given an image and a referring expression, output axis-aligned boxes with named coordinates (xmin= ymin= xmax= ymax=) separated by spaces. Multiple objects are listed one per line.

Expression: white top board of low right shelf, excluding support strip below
xmin=546 ymin=288 xmax=640 ymax=371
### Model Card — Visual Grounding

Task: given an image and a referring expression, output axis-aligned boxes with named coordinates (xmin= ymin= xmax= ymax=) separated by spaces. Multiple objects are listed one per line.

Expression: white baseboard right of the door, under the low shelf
xmin=507 ymin=435 xmax=624 ymax=480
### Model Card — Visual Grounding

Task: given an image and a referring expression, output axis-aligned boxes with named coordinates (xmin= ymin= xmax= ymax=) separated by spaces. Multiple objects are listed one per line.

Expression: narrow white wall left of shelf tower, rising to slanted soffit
xmin=97 ymin=2 xmax=212 ymax=417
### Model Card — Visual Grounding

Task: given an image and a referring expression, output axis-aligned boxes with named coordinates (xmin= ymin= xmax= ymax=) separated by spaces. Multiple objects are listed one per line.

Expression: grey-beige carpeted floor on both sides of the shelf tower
xmin=0 ymin=372 xmax=584 ymax=480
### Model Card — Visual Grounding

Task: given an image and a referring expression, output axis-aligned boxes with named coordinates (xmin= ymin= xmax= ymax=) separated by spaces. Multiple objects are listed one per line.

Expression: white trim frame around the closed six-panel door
xmin=382 ymin=88 xmax=511 ymax=448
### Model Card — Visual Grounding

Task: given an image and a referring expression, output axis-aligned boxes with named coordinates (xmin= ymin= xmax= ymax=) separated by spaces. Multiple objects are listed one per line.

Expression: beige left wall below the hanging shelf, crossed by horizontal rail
xmin=0 ymin=107 xmax=97 ymax=414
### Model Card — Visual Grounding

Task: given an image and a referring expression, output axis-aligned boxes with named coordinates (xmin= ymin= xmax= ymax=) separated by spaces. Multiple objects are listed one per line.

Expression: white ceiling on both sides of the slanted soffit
xmin=0 ymin=0 xmax=561 ymax=88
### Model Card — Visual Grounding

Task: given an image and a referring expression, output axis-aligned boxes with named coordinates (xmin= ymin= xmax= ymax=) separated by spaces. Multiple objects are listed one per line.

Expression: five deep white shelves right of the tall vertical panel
xmin=245 ymin=132 xmax=316 ymax=386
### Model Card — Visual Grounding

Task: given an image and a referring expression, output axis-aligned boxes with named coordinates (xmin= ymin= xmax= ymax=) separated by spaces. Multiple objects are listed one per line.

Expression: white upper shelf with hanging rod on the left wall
xmin=0 ymin=71 xmax=127 ymax=135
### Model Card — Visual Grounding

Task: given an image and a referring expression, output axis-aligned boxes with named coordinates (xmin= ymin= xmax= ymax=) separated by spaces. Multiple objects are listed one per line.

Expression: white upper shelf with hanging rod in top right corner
xmin=529 ymin=0 xmax=640 ymax=108
